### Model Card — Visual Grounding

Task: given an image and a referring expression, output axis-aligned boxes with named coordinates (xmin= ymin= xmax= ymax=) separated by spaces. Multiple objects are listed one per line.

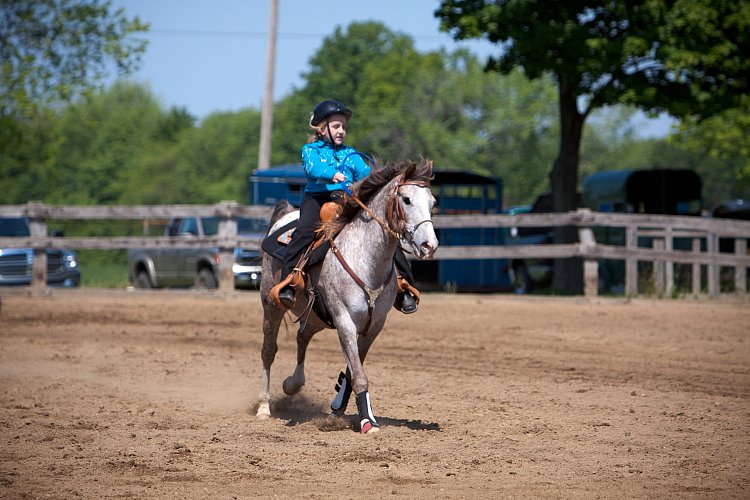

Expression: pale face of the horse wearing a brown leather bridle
xmin=398 ymin=184 xmax=438 ymax=259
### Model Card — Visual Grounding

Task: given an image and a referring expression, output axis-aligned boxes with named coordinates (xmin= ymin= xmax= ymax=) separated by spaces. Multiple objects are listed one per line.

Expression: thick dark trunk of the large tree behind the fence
xmin=549 ymin=75 xmax=586 ymax=294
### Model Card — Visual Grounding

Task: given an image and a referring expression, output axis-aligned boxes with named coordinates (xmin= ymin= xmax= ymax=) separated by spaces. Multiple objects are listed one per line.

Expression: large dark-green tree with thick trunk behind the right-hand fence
xmin=435 ymin=0 xmax=750 ymax=291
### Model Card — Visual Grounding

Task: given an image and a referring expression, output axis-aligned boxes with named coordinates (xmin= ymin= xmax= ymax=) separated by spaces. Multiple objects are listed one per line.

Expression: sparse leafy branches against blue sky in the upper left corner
xmin=0 ymin=0 xmax=147 ymax=117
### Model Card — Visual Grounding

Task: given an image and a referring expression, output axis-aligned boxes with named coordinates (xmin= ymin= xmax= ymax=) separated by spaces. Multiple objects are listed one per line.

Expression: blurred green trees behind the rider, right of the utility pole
xmin=273 ymin=23 xmax=557 ymax=203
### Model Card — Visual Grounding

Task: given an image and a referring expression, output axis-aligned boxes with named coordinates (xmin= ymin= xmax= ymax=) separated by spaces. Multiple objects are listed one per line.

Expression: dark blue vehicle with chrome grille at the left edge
xmin=0 ymin=217 xmax=81 ymax=287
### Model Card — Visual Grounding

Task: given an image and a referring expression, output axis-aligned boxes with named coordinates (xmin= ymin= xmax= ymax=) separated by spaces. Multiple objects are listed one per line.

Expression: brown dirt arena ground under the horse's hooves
xmin=0 ymin=290 xmax=750 ymax=499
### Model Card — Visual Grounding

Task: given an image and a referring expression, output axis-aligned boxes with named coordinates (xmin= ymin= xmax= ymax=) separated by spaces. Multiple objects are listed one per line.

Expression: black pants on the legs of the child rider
xmin=281 ymin=193 xmax=414 ymax=286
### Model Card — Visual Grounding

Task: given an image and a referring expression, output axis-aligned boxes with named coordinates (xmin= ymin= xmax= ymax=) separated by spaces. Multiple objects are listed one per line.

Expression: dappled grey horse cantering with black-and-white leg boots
xmin=256 ymin=158 xmax=438 ymax=434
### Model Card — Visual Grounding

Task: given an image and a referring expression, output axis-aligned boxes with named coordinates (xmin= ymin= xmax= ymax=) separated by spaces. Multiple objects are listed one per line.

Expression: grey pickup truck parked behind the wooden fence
xmin=128 ymin=217 xmax=267 ymax=289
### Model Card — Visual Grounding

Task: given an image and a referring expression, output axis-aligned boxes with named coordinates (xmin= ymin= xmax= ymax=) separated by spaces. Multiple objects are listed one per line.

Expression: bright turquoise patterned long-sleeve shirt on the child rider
xmin=302 ymin=140 xmax=370 ymax=194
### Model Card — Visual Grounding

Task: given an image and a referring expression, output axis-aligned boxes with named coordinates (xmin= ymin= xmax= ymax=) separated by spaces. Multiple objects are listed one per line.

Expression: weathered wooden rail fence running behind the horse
xmin=0 ymin=202 xmax=750 ymax=298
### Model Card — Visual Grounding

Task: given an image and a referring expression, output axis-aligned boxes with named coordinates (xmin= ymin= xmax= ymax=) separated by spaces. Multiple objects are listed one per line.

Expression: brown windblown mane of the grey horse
xmin=321 ymin=158 xmax=433 ymax=236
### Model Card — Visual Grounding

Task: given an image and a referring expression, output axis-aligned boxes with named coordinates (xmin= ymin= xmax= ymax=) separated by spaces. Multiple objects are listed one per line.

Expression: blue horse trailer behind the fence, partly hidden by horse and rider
xmin=249 ymin=165 xmax=512 ymax=291
